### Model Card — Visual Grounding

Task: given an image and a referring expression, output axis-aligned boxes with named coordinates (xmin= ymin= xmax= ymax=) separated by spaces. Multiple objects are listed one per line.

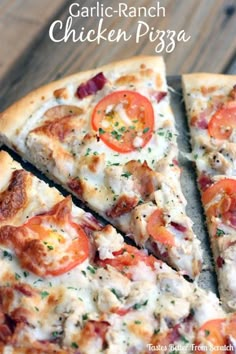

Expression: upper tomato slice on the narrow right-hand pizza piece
xmin=208 ymin=101 xmax=236 ymax=140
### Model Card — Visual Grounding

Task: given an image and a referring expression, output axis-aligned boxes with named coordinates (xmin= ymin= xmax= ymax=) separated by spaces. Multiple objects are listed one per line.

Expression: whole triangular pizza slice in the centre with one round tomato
xmin=0 ymin=57 xmax=202 ymax=278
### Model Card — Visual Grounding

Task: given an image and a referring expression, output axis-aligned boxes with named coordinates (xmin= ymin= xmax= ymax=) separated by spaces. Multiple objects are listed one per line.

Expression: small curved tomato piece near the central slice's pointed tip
xmin=147 ymin=209 xmax=175 ymax=247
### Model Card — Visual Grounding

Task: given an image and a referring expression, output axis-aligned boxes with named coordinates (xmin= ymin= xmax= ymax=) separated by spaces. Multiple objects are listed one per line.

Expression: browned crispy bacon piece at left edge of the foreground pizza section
xmin=0 ymin=170 xmax=27 ymax=222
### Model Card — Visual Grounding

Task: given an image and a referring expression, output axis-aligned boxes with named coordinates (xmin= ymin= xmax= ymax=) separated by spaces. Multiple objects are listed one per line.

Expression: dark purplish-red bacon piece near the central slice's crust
xmin=76 ymin=72 xmax=107 ymax=99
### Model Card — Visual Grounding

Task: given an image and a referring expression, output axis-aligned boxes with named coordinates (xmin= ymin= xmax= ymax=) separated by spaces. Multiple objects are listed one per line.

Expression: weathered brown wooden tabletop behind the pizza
xmin=0 ymin=0 xmax=236 ymax=110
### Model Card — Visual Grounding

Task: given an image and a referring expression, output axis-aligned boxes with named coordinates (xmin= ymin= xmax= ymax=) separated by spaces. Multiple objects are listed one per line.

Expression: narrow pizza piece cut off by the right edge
xmin=183 ymin=74 xmax=236 ymax=310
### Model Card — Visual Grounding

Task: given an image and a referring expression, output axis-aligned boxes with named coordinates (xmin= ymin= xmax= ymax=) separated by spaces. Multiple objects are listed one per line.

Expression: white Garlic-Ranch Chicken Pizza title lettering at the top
xmin=49 ymin=1 xmax=191 ymax=53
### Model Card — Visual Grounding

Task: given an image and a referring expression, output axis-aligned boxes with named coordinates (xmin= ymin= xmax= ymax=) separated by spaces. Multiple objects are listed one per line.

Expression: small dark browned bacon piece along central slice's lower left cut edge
xmin=106 ymin=195 xmax=138 ymax=218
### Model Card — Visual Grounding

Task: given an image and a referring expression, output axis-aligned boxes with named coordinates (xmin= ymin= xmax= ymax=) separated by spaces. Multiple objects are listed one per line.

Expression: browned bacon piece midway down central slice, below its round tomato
xmin=125 ymin=160 xmax=158 ymax=200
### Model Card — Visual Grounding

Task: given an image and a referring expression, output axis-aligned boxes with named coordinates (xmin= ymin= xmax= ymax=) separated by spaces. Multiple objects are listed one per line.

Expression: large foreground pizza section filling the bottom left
xmin=0 ymin=152 xmax=236 ymax=354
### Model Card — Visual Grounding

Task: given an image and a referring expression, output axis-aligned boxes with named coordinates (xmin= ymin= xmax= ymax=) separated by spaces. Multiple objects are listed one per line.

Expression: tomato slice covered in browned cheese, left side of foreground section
xmin=17 ymin=197 xmax=89 ymax=277
